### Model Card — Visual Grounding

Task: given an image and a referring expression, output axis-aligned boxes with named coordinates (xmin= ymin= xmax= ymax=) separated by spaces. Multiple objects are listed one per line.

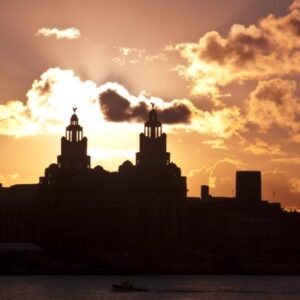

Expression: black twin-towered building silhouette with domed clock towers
xmin=37 ymin=109 xmax=187 ymax=253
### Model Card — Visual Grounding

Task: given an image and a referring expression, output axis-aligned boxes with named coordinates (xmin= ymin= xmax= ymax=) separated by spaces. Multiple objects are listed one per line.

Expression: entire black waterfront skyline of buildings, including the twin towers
xmin=0 ymin=107 xmax=300 ymax=272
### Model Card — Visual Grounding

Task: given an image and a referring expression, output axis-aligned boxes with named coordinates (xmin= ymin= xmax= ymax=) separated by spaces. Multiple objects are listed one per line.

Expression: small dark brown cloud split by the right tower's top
xmin=99 ymin=89 xmax=192 ymax=124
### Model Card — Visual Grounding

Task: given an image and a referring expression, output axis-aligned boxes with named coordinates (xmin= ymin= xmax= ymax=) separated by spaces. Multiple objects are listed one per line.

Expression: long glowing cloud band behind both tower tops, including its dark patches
xmin=0 ymin=68 xmax=244 ymax=139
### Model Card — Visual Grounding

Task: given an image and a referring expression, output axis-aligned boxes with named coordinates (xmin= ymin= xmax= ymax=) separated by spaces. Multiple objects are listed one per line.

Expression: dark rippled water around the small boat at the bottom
xmin=0 ymin=276 xmax=300 ymax=300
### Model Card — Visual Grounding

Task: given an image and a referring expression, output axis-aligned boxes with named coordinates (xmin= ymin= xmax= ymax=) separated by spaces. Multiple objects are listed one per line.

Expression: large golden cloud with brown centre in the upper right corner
xmin=170 ymin=1 xmax=300 ymax=96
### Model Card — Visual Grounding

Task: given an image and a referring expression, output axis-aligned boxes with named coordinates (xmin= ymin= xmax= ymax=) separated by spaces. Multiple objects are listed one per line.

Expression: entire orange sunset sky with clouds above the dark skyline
xmin=0 ymin=0 xmax=300 ymax=209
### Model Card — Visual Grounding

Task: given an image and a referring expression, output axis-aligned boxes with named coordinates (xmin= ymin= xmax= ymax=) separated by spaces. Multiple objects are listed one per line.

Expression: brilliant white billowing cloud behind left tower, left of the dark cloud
xmin=0 ymin=68 xmax=100 ymax=137
